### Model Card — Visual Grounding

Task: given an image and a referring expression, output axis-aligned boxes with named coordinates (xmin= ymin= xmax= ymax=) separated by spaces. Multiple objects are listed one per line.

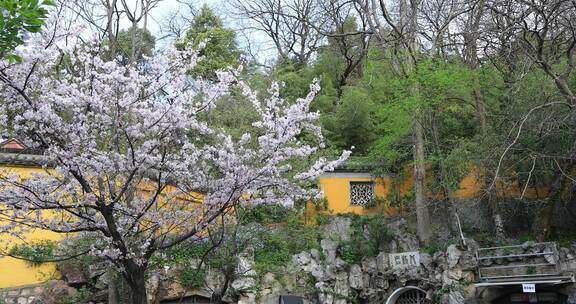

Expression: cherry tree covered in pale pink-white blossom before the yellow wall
xmin=0 ymin=16 xmax=350 ymax=304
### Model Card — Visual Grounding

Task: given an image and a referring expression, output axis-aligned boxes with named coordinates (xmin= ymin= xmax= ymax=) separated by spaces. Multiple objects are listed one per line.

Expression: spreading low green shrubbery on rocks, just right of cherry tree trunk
xmin=152 ymin=209 xmax=320 ymax=288
